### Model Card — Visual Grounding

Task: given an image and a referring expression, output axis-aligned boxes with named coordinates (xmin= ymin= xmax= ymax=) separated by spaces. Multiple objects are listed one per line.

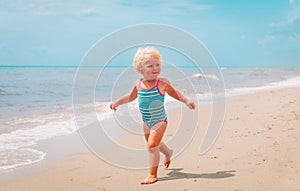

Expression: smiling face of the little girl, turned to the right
xmin=141 ymin=58 xmax=161 ymax=80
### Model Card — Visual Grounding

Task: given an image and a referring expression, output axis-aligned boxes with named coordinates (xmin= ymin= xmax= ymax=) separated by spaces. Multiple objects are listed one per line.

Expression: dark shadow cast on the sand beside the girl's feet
xmin=158 ymin=168 xmax=235 ymax=181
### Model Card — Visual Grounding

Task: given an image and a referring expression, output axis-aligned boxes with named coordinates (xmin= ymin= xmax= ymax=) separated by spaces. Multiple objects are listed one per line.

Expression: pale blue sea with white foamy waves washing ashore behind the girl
xmin=0 ymin=64 xmax=300 ymax=172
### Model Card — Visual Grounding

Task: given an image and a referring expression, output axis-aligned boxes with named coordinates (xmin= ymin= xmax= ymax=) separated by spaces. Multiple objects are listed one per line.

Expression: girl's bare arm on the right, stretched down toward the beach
xmin=164 ymin=79 xmax=196 ymax=109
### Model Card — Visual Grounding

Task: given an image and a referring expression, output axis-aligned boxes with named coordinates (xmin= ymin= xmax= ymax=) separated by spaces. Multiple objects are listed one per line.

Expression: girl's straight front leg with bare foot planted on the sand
xmin=141 ymin=122 xmax=167 ymax=184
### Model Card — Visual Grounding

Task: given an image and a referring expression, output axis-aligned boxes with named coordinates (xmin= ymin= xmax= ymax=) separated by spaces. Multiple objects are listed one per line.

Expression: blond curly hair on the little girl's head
xmin=133 ymin=46 xmax=161 ymax=74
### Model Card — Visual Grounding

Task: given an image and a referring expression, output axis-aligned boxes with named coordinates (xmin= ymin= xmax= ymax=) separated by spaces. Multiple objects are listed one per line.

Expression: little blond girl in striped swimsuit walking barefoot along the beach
xmin=110 ymin=47 xmax=195 ymax=184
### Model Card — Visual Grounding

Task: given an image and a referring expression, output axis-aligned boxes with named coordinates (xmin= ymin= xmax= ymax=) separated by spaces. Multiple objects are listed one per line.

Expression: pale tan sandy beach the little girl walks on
xmin=0 ymin=88 xmax=300 ymax=191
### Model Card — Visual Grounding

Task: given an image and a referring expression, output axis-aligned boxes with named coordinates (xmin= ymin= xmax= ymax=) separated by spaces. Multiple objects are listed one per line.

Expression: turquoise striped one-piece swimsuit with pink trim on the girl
xmin=138 ymin=79 xmax=167 ymax=129
